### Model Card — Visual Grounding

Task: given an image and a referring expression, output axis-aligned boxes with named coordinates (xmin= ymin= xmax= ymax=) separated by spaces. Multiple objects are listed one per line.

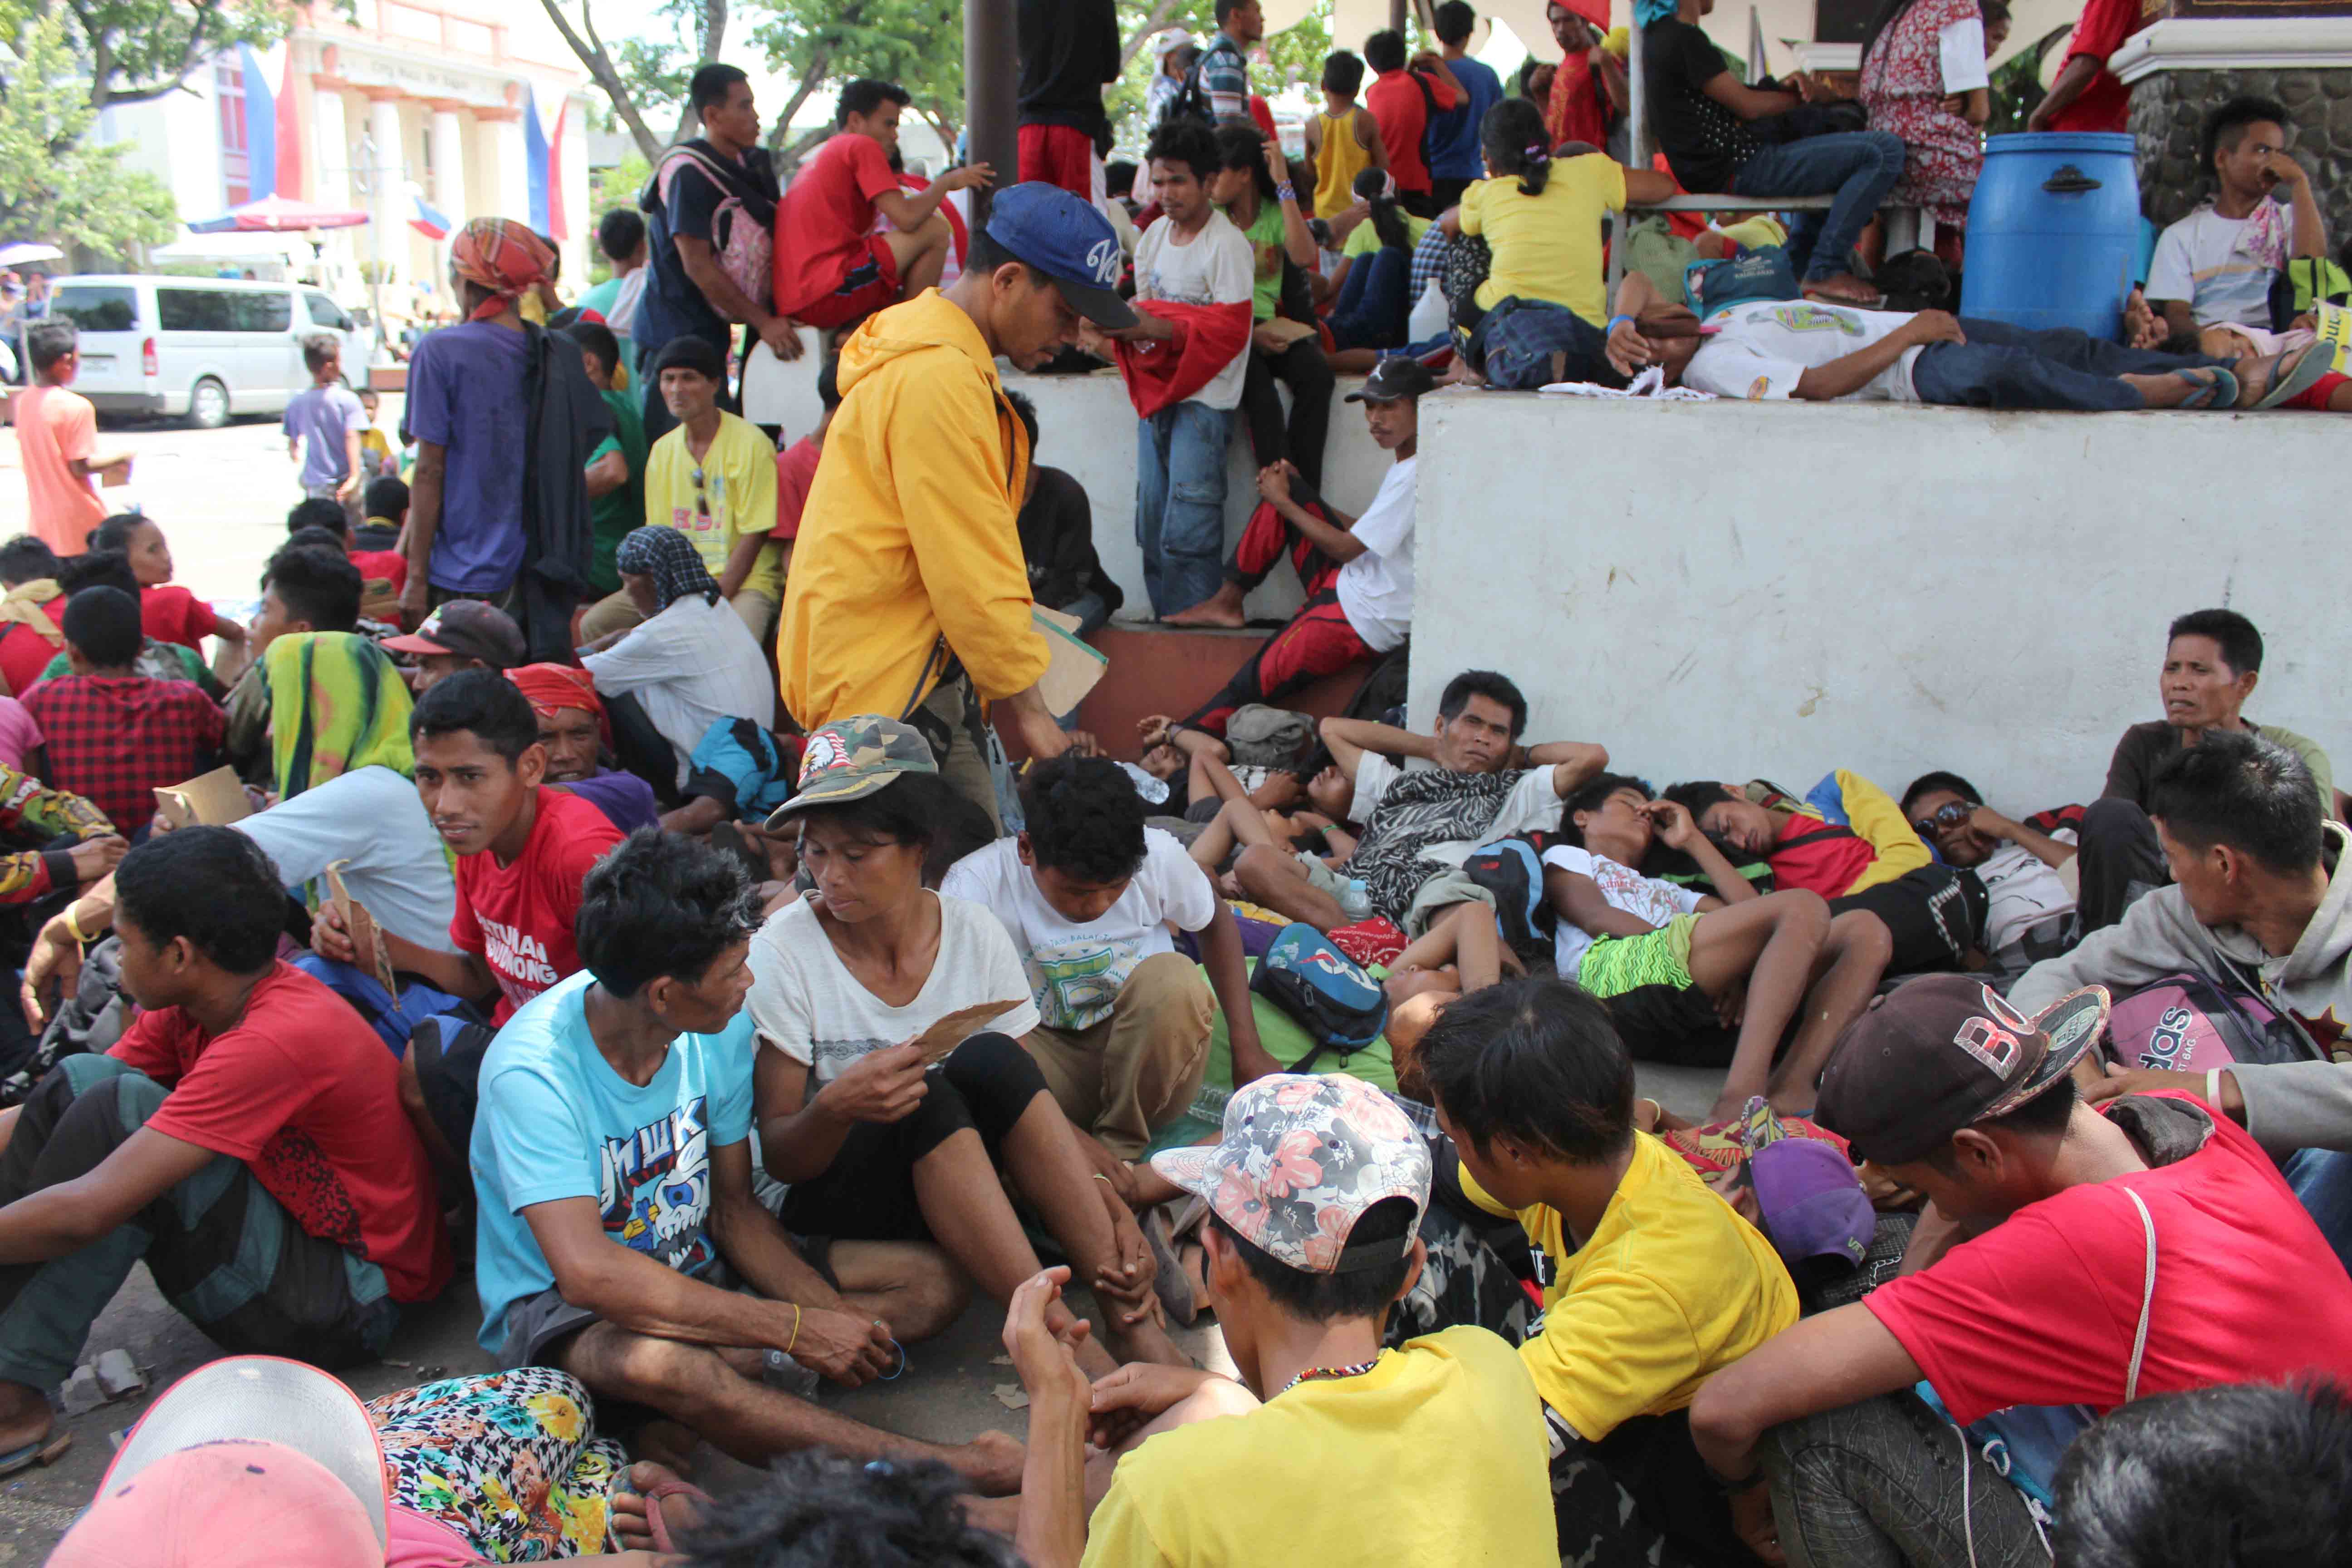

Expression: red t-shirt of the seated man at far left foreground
xmin=108 ymin=964 xmax=449 ymax=1303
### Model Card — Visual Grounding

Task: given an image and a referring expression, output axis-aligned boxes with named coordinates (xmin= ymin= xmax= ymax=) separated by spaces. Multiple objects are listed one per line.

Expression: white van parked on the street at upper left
xmin=49 ymin=273 xmax=367 ymax=430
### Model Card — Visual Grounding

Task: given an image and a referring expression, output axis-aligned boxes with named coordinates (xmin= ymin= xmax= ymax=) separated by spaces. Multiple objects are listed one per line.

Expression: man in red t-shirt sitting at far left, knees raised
xmin=0 ymin=828 xmax=449 ymax=1474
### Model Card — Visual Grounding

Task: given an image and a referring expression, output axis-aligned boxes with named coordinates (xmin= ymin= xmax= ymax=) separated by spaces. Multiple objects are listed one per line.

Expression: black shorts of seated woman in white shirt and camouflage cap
xmin=781 ymin=1032 xmax=1051 ymax=1241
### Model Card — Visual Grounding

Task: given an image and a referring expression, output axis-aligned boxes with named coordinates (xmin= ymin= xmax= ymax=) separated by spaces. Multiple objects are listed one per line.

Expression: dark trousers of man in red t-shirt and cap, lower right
xmin=1759 ymin=1392 xmax=2048 ymax=1568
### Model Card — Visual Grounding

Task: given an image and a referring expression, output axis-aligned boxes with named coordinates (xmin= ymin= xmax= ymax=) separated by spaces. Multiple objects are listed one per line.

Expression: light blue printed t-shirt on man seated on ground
xmin=470 ymin=971 xmax=753 ymax=1354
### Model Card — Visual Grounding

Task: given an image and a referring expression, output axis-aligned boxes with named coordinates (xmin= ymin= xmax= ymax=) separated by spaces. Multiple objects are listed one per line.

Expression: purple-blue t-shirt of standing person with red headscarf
xmin=405 ymin=322 xmax=529 ymax=593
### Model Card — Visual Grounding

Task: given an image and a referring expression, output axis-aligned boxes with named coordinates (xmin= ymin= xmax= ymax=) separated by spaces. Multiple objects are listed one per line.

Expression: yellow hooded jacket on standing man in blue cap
xmin=776 ymin=289 xmax=1049 ymax=729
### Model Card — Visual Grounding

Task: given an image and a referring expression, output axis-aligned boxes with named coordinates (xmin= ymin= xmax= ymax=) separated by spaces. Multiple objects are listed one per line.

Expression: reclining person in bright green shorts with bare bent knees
xmin=1543 ymin=774 xmax=1886 ymax=1122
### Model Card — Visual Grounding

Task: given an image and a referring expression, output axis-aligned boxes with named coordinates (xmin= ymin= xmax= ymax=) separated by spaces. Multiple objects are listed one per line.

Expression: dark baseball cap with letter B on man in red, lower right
xmin=1813 ymin=975 xmax=2107 ymax=1166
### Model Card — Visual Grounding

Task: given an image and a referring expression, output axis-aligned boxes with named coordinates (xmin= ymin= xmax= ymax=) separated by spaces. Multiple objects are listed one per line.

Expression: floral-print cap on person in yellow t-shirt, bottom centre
xmin=1152 ymin=1072 xmax=1430 ymax=1274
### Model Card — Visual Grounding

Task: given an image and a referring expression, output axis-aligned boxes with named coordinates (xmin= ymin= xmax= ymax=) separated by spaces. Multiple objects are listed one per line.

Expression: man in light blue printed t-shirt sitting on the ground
xmin=473 ymin=828 xmax=1021 ymax=1490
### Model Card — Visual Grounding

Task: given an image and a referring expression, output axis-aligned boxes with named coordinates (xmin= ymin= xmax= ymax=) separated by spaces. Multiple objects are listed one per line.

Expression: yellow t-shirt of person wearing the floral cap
xmin=1084 ymin=1328 xmax=1559 ymax=1568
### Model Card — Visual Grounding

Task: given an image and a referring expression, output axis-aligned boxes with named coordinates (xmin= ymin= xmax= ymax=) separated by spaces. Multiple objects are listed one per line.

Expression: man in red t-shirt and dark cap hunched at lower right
xmin=1691 ymin=973 xmax=2352 ymax=1568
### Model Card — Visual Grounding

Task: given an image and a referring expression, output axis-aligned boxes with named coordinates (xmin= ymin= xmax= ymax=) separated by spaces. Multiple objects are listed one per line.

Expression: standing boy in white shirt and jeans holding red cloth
xmin=1079 ymin=120 xmax=1251 ymax=616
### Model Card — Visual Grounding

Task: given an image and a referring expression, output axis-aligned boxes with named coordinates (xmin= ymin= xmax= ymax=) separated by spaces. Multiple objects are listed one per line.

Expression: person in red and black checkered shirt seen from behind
xmin=24 ymin=588 xmax=223 ymax=837
